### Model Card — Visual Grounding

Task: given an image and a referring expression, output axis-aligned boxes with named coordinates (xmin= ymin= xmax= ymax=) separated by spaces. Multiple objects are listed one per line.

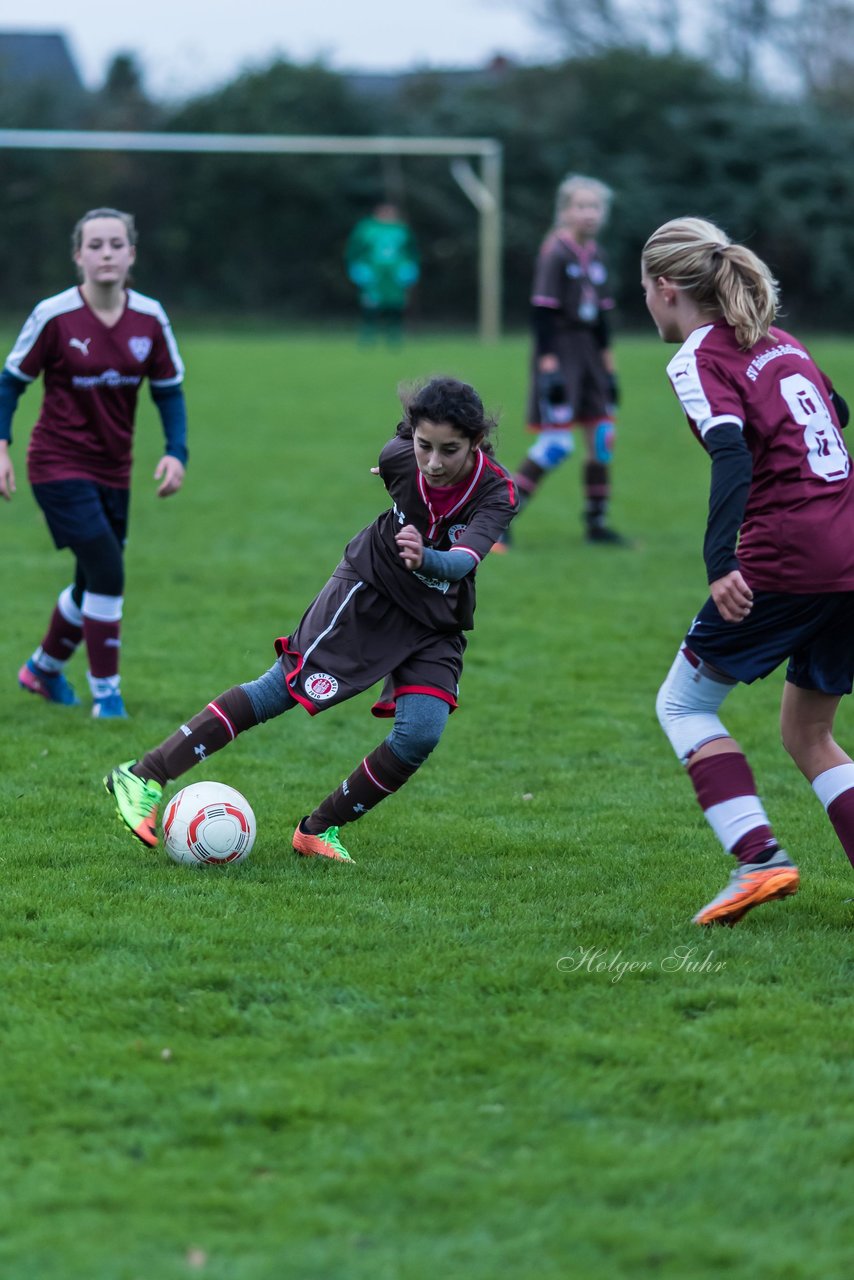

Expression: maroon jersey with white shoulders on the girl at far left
xmin=6 ymin=287 xmax=184 ymax=489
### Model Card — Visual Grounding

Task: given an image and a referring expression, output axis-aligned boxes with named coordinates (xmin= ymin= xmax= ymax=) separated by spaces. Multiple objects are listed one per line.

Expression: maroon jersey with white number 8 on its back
xmin=667 ymin=320 xmax=854 ymax=594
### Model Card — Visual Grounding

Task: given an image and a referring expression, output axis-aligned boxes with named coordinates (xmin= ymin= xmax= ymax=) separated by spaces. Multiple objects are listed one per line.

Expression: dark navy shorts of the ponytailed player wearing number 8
xmin=685 ymin=591 xmax=854 ymax=695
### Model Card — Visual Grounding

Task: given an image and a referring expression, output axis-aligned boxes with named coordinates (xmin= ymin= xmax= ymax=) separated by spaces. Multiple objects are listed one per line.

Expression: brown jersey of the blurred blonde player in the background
xmin=531 ymin=230 xmax=613 ymax=329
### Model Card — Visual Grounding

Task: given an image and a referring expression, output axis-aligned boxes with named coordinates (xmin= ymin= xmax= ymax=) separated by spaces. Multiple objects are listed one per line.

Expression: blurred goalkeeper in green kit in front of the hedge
xmin=346 ymin=201 xmax=420 ymax=344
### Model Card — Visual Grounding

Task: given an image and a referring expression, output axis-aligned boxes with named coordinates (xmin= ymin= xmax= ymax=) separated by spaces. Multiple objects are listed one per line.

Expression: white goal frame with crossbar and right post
xmin=0 ymin=129 xmax=503 ymax=342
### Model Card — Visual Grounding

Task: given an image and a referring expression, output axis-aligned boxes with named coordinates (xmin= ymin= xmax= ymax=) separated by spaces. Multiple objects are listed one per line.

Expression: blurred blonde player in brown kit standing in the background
xmin=501 ymin=174 xmax=627 ymax=547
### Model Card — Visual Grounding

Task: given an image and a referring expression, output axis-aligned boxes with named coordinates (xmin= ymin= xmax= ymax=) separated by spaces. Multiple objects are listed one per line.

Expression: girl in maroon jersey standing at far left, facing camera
xmin=0 ymin=209 xmax=187 ymax=719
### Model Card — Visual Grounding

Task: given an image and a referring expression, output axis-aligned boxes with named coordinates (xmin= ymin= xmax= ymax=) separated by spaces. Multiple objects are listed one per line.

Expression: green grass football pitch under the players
xmin=0 ymin=330 xmax=854 ymax=1280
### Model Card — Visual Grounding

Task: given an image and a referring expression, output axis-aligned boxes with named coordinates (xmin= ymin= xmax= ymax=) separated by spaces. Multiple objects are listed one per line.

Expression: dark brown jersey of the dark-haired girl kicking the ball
xmin=344 ymin=436 xmax=519 ymax=631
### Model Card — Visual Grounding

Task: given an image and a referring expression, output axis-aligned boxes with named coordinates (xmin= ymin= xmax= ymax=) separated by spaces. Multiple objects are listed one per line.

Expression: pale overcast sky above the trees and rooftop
xmin=0 ymin=0 xmax=548 ymax=99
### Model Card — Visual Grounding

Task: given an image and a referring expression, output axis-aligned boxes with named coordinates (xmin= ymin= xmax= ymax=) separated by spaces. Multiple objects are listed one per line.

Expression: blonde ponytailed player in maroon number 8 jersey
xmin=643 ymin=218 xmax=854 ymax=924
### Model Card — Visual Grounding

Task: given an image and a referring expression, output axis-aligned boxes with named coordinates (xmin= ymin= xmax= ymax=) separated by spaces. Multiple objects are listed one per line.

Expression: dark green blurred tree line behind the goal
xmin=0 ymin=45 xmax=854 ymax=329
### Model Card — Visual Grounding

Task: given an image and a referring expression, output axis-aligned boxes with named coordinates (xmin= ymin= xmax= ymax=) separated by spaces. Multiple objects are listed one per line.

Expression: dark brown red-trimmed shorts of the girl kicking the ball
xmin=275 ymin=564 xmax=466 ymax=716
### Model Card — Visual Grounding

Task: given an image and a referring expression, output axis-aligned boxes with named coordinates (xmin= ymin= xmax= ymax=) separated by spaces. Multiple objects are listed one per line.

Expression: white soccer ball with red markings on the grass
xmin=163 ymin=782 xmax=255 ymax=867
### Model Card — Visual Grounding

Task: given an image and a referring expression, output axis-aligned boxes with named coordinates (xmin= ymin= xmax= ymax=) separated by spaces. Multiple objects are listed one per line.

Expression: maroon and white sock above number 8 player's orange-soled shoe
xmin=688 ymin=750 xmax=778 ymax=863
